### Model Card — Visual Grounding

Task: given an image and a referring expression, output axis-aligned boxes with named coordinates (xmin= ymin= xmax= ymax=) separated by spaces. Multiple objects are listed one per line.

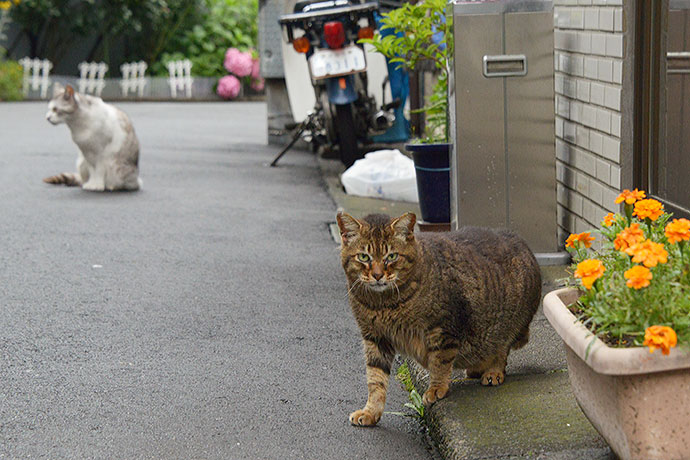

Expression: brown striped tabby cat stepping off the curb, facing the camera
xmin=337 ymin=213 xmax=541 ymax=426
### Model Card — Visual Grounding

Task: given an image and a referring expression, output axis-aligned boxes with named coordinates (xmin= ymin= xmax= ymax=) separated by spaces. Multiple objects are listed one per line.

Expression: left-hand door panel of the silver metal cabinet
xmin=451 ymin=14 xmax=508 ymax=227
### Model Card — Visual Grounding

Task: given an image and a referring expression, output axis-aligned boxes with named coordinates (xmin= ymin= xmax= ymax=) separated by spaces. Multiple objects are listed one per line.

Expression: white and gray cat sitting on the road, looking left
xmin=43 ymin=83 xmax=141 ymax=192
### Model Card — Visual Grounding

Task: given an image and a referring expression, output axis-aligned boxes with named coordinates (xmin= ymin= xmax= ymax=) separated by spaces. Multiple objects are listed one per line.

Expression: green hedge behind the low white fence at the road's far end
xmin=9 ymin=0 xmax=258 ymax=76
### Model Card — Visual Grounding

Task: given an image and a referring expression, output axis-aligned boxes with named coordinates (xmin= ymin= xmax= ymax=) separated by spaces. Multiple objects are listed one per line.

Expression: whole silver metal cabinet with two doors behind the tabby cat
xmin=451 ymin=2 xmax=563 ymax=252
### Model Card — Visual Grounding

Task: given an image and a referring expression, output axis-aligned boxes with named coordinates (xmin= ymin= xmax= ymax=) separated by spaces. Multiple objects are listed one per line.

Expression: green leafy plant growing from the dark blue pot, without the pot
xmin=360 ymin=0 xmax=453 ymax=142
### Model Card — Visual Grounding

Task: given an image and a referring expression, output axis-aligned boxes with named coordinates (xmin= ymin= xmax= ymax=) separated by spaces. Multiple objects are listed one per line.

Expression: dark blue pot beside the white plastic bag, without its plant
xmin=405 ymin=144 xmax=452 ymax=223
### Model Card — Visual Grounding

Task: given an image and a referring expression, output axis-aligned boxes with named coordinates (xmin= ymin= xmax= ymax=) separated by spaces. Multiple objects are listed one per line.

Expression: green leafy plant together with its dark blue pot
xmin=361 ymin=0 xmax=453 ymax=223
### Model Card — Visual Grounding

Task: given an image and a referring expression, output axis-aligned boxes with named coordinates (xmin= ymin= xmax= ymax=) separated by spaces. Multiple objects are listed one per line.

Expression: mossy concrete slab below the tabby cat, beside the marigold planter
xmin=408 ymin=361 xmax=615 ymax=460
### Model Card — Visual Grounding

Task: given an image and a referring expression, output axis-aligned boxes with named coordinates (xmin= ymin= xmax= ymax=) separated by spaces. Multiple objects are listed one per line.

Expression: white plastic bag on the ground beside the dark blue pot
xmin=340 ymin=150 xmax=419 ymax=203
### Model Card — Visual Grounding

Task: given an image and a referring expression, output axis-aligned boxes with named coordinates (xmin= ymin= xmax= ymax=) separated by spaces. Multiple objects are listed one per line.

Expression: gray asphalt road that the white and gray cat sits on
xmin=0 ymin=103 xmax=430 ymax=460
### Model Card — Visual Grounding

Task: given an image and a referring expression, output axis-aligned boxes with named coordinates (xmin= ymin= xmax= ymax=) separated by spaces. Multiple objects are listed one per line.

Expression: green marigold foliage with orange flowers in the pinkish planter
xmin=567 ymin=197 xmax=690 ymax=346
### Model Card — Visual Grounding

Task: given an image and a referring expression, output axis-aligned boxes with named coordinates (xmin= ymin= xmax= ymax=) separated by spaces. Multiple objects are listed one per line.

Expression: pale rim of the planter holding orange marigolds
xmin=544 ymin=287 xmax=690 ymax=375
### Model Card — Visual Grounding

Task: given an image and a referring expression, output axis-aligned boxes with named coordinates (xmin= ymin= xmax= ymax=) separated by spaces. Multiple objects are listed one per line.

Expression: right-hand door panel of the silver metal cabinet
xmin=505 ymin=12 xmax=558 ymax=252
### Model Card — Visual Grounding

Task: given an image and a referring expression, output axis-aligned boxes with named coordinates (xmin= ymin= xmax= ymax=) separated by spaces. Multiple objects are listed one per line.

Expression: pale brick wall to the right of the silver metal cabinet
xmin=554 ymin=0 xmax=626 ymax=242
